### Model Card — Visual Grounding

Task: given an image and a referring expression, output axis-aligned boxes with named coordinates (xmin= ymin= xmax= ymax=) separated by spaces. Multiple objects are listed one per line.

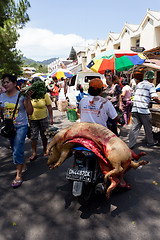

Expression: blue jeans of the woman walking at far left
xmin=10 ymin=125 xmax=28 ymax=164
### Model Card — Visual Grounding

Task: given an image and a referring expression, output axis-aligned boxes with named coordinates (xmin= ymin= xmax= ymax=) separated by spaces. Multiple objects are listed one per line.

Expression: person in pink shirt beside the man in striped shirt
xmin=121 ymin=79 xmax=132 ymax=125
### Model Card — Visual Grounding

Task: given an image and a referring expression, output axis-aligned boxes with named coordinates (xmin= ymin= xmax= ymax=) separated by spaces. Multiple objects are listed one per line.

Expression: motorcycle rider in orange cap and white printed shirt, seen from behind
xmin=79 ymin=78 xmax=119 ymax=127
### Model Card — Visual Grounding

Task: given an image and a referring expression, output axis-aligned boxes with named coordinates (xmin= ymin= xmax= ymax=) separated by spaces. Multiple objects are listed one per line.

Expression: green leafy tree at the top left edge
xmin=0 ymin=0 xmax=30 ymax=75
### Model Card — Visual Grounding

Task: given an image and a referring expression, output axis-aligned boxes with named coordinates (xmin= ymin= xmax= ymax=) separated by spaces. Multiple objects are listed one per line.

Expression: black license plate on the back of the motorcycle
xmin=66 ymin=168 xmax=92 ymax=182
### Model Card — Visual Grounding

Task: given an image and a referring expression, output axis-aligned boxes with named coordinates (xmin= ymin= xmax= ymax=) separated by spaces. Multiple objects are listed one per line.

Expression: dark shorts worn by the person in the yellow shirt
xmin=29 ymin=117 xmax=49 ymax=141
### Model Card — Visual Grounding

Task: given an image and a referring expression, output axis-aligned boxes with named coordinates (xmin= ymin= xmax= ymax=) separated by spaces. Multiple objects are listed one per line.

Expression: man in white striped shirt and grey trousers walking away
xmin=129 ymin=71 xmax=160 ymax=148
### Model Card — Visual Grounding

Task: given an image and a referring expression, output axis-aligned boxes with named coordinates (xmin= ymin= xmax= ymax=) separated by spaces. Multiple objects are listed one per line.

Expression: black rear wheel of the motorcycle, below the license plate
xmin=77 ymin=182 xmax=94 ymax=206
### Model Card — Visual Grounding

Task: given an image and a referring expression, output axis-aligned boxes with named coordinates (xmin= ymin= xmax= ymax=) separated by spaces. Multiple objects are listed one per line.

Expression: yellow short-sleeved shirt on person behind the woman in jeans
xmin=29 ymin=93 xmax=52 ymax=120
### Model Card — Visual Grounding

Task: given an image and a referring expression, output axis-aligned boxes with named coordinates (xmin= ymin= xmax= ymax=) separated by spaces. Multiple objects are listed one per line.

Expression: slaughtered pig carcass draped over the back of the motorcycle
xmin=47 ymin=122 xmax=148 ymax=198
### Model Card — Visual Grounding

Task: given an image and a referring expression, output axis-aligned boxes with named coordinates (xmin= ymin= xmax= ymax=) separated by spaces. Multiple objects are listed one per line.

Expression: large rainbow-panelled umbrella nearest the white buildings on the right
xmin=87 ymin=49 xmax=146 ymax=74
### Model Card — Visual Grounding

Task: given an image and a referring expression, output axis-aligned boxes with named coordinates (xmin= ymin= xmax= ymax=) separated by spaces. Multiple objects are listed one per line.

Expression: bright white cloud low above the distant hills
xmin=17 ymin=28 xmax=94 ymax=60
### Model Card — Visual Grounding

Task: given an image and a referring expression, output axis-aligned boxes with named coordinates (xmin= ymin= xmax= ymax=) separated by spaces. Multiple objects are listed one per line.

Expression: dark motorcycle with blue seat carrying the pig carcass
xmin=66 ymin=145 xmax=105 ymax=205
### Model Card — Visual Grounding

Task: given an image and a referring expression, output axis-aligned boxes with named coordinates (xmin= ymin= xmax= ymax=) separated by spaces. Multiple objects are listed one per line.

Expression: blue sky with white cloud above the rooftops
xmin=17 ymin=0 xmax=160 ymax=61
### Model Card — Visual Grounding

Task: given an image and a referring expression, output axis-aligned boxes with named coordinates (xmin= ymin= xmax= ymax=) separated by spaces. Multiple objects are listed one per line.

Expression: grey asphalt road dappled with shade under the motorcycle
xmin=0 ymin=111 xmax=160 ymax=240
